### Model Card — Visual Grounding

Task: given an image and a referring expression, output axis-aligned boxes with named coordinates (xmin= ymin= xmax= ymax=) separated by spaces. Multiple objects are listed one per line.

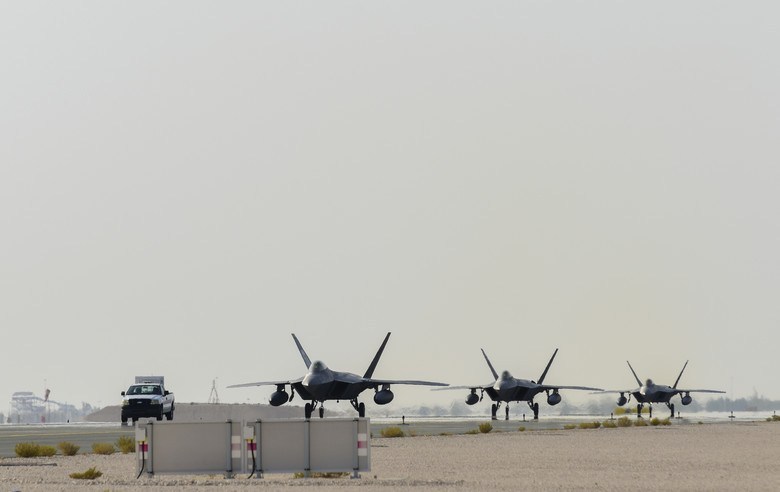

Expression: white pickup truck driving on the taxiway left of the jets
xmin=122 ymin=376 xmax=174 ymax=424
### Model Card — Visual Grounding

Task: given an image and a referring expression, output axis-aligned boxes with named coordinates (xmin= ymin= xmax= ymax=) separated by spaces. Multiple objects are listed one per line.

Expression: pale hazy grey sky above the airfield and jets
xmin=0 ymin=0 xmax=780 ymax=414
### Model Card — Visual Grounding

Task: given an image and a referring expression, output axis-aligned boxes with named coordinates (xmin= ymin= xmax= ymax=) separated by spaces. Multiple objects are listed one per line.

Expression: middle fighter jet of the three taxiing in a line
xmin=442 ymin=349 xmax=602 ymax=420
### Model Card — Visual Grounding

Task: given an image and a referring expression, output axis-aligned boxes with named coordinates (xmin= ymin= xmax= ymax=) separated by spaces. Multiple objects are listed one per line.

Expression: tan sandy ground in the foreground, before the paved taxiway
xmin=0 ymin=422 xmax=780 ymax=491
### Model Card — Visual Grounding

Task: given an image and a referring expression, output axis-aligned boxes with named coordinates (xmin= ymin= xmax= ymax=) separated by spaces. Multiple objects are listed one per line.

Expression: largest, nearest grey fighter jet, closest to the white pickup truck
xmin=228 ymin=332 xmax=447 ymax=419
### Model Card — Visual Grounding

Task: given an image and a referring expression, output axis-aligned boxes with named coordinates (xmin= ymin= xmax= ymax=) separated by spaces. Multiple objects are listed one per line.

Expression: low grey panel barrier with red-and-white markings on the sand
xmin=136 ymin=418 xmax=371 ymax=478
